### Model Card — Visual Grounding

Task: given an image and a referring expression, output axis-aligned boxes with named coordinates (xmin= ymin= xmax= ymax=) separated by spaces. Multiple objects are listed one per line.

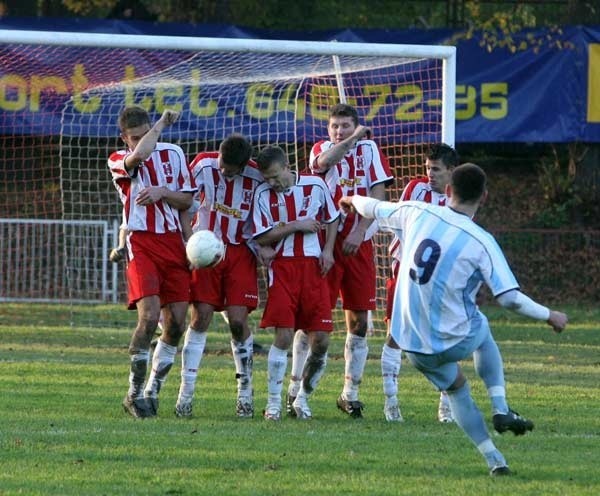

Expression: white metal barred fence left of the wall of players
xmin=0 ymin=219 xmax=119 ymax=303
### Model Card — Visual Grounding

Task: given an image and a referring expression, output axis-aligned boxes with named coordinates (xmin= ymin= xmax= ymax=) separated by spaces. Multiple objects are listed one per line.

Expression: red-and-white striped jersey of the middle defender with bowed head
xmin=253 ymin=174 xmax=339 ymax=257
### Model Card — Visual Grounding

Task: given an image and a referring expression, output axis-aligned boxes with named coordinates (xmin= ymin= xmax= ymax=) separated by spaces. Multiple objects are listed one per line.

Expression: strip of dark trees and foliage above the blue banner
xmin=28 ymin=0 xmax=600 ymax=29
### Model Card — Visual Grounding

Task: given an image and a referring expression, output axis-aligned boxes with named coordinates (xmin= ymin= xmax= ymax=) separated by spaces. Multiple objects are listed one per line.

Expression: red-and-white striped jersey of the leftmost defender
xmin=108 ymin=143 xmax=196 ymax=234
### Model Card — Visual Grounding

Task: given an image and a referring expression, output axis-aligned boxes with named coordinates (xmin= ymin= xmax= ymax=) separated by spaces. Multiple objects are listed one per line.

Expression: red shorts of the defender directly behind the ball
xmin=190 ymin=244 xmax=258 ymax=312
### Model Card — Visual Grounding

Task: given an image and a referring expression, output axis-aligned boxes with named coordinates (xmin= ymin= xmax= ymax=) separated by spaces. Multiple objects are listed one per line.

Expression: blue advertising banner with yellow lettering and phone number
xmin=0 ymin=18 xmax=600 ymax=142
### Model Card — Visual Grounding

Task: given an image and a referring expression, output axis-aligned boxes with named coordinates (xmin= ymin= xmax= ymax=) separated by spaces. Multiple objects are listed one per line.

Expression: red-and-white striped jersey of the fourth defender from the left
xmin=309 ymin=140 xmax=393 ymax=240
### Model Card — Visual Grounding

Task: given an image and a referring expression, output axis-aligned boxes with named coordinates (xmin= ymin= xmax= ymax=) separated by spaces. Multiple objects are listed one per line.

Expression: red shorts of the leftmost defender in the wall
xmin=127 ymin=231 xmax=190 ymax=310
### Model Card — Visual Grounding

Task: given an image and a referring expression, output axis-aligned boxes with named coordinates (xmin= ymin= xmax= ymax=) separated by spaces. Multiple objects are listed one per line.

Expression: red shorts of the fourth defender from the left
xmin=327 ymin=236 xmax=376 ymax=312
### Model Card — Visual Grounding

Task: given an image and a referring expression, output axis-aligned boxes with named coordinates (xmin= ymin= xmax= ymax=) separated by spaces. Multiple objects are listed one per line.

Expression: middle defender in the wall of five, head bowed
xmin=253 ymin=146 xmax=339 ymax=421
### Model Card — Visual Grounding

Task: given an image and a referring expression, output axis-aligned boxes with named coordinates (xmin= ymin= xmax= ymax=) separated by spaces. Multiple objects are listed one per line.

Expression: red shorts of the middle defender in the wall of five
xmin=260 ymin=257 xmax=333 ymax=332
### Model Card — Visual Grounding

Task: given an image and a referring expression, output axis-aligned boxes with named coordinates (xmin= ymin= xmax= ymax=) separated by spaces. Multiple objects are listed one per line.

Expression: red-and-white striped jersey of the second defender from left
xmin=189 ymin=152 xmax=263 ymax=245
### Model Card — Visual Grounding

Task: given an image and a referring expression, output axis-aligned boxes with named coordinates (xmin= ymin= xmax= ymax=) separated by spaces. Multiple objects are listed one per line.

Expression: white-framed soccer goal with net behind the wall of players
xmin=0 ymin=30 xmax=455 ymax=329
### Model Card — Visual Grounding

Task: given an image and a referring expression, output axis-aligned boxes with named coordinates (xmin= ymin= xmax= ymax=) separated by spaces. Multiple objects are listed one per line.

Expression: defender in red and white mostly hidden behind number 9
xmin=381 ymin=143 xmax=458 ymax=423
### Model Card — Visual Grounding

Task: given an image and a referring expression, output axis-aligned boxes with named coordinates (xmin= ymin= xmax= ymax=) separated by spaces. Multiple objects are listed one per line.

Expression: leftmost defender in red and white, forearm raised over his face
xmin=108 ymin=106 xmax=196 ymax=418
